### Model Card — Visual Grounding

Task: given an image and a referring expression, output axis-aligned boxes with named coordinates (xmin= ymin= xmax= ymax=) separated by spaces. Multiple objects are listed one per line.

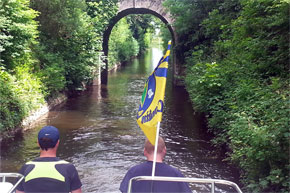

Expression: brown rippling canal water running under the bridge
xmin=0 ymin=48 xmax=238 ymax=193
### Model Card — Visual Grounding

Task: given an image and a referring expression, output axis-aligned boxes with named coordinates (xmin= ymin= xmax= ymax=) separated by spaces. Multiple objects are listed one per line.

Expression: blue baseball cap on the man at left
xmin=38 ymin=126 xmax=59 ymax=148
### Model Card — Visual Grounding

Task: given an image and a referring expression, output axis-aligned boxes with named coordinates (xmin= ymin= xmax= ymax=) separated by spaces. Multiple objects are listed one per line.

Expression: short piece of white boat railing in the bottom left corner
xmin=0 ymin=173 xmax=24 ymax=193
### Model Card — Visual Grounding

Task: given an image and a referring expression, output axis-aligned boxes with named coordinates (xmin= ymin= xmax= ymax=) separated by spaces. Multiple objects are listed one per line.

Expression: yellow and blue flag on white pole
xmin=137 ymin=41 xmax=171 ymax=145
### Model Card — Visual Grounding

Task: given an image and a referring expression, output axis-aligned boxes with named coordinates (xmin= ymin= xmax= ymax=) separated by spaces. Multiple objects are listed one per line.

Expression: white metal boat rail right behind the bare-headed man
xmin=128 ymin=176 xmax=242 ymax=193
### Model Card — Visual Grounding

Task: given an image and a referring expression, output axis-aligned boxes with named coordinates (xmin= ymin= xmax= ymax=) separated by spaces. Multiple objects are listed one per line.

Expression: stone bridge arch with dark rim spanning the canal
xmin=101 ymin=0 xmax=178 ymax=84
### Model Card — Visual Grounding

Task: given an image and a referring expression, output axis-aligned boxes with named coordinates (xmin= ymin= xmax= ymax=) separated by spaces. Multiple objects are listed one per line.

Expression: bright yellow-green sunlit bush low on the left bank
xmin=0 ymin=66 xmax=45 ymax=131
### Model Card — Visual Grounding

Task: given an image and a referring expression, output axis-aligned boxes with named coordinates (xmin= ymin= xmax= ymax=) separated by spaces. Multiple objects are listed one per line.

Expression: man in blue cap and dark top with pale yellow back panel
xmin=16 ymin=126 xmax=82 ymax=193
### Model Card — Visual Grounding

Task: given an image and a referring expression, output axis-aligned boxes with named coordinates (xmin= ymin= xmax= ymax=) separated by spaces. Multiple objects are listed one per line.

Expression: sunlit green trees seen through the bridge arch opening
xmin=109 ymin=14 xmax=161 ymax=68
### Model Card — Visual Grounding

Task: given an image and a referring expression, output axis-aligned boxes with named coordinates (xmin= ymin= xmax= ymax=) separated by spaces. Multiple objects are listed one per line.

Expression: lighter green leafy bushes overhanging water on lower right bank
xmin=186 ymin=60 xmax=290 ymax=192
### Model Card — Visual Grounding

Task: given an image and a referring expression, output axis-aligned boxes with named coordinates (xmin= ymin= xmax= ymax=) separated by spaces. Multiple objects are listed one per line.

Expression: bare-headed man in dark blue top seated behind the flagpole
xmin=120 ymin=137 xmax=192 ymax=193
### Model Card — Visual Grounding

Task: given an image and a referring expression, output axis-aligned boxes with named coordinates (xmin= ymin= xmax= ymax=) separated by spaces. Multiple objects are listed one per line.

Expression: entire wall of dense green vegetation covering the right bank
xmin=165 ymin=0 xmax=290 ymax=192
